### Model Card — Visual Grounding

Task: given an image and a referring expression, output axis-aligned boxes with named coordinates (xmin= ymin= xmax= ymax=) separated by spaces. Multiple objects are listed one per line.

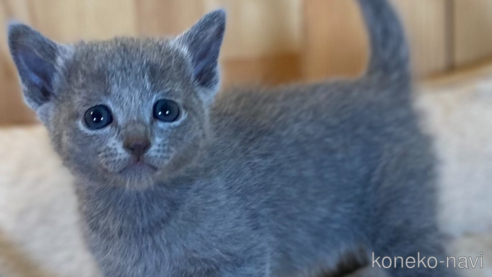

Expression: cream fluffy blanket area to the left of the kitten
xmin=0 ymin=126 xmax=99 ymax=277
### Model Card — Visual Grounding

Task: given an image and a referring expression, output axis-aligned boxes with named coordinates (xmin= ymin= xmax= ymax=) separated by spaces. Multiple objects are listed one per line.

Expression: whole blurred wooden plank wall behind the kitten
xmin=0 ymin=0 xmax=492 ymax=125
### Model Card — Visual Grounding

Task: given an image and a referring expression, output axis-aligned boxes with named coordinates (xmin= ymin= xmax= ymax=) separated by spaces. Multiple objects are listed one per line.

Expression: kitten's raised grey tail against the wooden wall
xmin=359 ymin=0 xmax=411 ymax=77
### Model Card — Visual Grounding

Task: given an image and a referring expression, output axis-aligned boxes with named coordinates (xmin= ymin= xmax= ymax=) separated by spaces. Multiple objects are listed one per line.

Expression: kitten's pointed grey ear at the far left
xmin=8 ymin=23 xmax=65 ymax=110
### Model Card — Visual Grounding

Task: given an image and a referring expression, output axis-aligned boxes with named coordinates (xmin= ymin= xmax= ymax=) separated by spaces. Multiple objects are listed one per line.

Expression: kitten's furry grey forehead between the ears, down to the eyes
xmin=61 ymin=38 xmax=196 ymax=118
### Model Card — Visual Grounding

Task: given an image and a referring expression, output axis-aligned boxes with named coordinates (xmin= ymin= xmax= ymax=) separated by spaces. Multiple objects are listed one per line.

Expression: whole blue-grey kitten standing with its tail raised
xmin=9 ymin=0 xmax=452 ymax=277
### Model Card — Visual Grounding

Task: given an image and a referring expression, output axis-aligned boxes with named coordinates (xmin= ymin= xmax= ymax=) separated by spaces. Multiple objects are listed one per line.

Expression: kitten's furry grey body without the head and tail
xmin=79 ymin=80 xmax=426 ymax=276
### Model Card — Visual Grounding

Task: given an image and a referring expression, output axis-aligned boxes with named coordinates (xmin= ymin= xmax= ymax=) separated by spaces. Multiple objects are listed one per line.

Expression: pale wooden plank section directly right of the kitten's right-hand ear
xmin=204 ymin=0 xmax=302 ymax=59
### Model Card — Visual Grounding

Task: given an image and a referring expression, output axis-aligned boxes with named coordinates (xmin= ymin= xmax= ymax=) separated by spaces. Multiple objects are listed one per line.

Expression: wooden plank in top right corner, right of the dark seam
xmin=452 ymin=0 xmax=492 ymax=66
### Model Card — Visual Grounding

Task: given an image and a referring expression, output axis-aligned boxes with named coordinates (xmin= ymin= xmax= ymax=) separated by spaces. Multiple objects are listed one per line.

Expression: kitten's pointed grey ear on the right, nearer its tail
xmin=176 ymin=10 xmax=226 ymax=92
